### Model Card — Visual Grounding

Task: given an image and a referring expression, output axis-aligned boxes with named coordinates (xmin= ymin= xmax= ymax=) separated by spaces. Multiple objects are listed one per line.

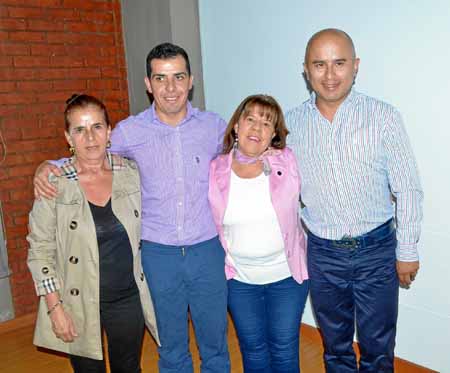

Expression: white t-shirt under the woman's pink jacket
xmin=223 ymin=171 xmax=291 ymax=285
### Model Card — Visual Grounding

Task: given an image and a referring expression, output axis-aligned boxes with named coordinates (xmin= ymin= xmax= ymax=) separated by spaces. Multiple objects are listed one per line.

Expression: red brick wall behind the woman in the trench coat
xmin=0 ymin=0 xmax=129 ymax=316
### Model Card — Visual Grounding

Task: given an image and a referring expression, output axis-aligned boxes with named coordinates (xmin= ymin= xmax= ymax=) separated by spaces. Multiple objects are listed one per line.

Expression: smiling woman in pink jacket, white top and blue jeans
xmin=209 ymin=95 xmax=308 ymax=373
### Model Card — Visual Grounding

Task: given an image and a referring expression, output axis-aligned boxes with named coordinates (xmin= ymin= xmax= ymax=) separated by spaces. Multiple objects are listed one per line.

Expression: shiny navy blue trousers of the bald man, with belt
xmin=308 ymin=221 xmax=399 ymax=373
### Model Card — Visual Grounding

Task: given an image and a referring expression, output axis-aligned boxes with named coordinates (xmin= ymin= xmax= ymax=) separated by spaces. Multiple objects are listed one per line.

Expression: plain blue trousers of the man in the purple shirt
xmin=141 ymin=237 xmax=230 ymax=373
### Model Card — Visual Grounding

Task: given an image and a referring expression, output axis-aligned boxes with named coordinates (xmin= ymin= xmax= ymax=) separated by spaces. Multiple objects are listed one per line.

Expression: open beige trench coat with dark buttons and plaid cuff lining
xmin=27 ymin=156 xmax=159 ymax=360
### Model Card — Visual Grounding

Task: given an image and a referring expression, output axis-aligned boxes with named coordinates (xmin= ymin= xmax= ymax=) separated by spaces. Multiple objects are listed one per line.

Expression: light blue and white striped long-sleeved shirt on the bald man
xmin=286 ymin=89 xmax=423 ymax=261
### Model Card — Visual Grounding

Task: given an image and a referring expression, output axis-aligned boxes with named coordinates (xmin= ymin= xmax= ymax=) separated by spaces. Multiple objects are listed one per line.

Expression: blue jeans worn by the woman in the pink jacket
xmin=228 ymin=277 xmax=308 ymax=373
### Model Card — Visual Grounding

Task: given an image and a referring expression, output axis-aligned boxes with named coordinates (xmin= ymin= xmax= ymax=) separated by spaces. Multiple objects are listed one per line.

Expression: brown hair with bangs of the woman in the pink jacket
xmin=222 ymin=94 xmax=289 ymax=154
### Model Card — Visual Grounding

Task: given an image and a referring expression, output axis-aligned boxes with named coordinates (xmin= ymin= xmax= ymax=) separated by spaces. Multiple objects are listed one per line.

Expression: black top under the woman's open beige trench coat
xmin=89 ymin=199 xmax=138 ymax=302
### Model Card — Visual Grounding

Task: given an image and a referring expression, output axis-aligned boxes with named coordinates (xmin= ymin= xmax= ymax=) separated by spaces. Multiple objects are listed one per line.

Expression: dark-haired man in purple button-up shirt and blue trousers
xmin=35 ymin=43 xmax=230 ymax=373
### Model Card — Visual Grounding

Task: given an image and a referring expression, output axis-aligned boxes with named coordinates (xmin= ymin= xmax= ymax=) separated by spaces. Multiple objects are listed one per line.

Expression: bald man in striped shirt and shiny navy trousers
xmin=286 ymin=29 xmax=423 ymax=373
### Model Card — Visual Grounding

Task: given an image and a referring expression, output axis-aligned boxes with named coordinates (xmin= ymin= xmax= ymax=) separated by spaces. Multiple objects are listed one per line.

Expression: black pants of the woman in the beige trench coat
xmin=69 ymin=293 xmax=145 ymax=373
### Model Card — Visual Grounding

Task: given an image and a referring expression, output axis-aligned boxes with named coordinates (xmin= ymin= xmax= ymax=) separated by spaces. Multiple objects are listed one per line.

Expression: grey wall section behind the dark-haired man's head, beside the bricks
xmin=121 ymin=0 xmax=205 ymax=114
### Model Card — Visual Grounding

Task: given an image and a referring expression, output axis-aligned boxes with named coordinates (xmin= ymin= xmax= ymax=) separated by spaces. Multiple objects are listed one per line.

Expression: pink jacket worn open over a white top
xmin=208 ymin=148 xmax=308 ymax=283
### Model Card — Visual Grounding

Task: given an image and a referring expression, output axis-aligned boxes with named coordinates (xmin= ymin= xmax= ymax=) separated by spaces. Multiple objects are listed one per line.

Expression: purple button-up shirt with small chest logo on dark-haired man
xmin=110 ymin=103 xmax=226 ymax=246
